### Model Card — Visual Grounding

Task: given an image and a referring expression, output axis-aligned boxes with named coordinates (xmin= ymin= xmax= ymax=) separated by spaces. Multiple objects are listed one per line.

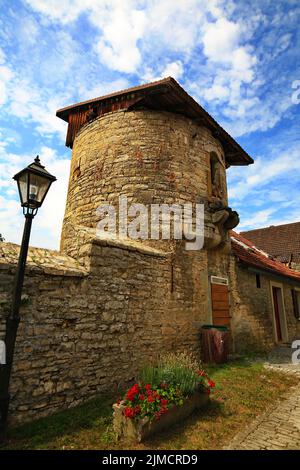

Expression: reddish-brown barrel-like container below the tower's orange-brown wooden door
xmin=201 ymin=325 xmax=230 ymax=364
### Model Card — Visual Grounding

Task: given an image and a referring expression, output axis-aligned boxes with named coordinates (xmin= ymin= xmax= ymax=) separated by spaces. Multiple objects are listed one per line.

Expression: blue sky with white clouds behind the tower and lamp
xmin=0 ymin=0 xmax=300 ymax=249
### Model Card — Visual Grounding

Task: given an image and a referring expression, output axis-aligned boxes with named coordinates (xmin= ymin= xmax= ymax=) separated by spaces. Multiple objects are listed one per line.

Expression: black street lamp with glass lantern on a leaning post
xmin=0 ymin=156 xmax=56 ymax=442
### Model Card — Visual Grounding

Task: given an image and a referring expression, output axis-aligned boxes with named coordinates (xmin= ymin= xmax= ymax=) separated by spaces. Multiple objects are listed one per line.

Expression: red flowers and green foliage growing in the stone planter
xmin=118 ymin=355 xmax=215 ymax=421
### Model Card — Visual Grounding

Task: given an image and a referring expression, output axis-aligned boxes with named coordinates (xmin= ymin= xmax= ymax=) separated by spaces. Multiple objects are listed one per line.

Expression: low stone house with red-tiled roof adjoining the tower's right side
xmin=230 ymin=232 xmax=300 ymax=352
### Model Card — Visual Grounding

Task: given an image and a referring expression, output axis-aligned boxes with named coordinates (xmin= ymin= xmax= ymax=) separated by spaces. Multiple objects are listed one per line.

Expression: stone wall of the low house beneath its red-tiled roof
xmin=230 ymin=255 xmax=300 ymax=352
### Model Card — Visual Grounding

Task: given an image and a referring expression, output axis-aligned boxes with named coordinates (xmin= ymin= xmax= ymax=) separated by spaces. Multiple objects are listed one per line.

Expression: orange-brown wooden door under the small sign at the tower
xmin=211 ymin=284 xmax=231 ymax=328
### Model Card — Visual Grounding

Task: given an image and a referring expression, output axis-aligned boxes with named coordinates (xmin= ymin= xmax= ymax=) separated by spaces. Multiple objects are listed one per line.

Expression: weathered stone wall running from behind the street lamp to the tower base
xmin=0 ymin=235 xmax=213 ymax=422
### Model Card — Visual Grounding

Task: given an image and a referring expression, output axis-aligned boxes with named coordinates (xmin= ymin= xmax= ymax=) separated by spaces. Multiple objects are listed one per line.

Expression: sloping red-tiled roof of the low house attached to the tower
xmin=231 ymin=230 xmax=300 ymax=282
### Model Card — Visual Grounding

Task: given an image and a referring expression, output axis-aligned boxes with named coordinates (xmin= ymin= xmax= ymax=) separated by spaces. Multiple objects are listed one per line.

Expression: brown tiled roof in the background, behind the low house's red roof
xmin=241 ymin=222 xmax=300 ymax=263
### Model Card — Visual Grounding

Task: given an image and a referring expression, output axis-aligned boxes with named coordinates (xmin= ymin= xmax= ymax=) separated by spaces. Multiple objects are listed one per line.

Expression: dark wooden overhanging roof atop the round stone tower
xmin=56 ymin=77 xmax=253 ymax=165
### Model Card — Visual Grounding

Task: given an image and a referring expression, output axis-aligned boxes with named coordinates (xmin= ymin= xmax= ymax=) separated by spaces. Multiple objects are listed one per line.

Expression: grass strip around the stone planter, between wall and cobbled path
xmin=3 ymin=360 xmax=298 ymax=450
